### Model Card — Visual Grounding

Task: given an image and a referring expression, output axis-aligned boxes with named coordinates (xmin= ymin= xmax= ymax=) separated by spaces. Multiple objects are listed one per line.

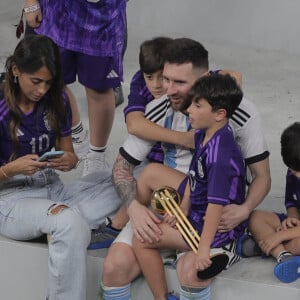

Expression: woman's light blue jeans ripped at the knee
xmin=0 ymin=169 xmax=120 ymax=300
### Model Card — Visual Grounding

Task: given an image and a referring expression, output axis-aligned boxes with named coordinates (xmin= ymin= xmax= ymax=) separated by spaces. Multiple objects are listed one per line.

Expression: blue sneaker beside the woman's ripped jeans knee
xmin=88 ymin=218 xmax=120 ymax=250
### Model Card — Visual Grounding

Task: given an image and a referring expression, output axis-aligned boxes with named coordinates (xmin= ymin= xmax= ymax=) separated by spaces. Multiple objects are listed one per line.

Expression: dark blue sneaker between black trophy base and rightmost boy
xmin=236 ymin=233 xmax=263 ymax=257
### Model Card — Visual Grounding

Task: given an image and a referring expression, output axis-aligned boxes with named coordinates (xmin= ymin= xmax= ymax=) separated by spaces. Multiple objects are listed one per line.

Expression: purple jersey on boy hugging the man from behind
xmin=124 ymin=70 xmax=164 ymax=163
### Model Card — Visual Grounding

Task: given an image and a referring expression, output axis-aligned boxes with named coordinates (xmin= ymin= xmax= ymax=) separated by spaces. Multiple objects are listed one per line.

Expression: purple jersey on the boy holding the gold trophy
xmin=188 ymin=125 xmax=246 ymax=248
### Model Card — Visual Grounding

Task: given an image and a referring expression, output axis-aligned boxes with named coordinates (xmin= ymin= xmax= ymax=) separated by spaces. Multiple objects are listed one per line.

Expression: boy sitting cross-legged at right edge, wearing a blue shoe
xmin=249 ymin=122 xmax=300 ymax=283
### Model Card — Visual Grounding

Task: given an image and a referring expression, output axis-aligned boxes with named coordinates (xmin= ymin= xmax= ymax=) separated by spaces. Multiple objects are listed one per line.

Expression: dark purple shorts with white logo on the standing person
xmin=60 ymin=48 xmax=123 ymax=91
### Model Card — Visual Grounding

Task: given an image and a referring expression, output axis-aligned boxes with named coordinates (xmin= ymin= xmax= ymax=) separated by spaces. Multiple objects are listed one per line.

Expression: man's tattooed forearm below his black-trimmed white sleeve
xmin=112 ymin=154 xmax=136 ymax=208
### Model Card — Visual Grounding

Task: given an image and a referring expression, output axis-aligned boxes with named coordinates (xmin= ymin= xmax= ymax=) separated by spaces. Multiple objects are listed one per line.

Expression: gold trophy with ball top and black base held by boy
xmin=151 ymin=186 xmax=229 ymax=280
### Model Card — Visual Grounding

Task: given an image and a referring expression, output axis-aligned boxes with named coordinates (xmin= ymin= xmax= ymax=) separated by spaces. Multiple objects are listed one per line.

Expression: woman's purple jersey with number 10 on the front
xmin=0 ymin=97 xmax=72 ymax=165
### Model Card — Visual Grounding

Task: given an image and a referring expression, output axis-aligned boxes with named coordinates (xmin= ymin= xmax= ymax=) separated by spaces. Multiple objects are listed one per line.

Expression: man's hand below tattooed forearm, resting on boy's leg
xmin=127 ymin=200 xmax=161 ymax=243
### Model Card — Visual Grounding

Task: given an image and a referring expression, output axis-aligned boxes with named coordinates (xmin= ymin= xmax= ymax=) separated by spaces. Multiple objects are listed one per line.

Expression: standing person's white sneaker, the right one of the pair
xmin=82 ymin=151 xmax=109 ymax=177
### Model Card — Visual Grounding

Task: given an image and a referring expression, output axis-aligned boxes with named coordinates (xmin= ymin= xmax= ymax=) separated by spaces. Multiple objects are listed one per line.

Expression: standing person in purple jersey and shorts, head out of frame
xmin=24 ymin=0 xmax=126 ymax=176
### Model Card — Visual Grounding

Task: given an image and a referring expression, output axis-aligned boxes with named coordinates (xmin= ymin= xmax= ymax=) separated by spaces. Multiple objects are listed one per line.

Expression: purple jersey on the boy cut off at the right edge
xmin=285 ymin=170 xmax=300 ymax=210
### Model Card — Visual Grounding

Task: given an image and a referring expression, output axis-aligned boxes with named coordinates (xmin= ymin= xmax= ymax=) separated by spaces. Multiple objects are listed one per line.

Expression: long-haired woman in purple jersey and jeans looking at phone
xmin=0 ymin=35 xmax=120 ymax=300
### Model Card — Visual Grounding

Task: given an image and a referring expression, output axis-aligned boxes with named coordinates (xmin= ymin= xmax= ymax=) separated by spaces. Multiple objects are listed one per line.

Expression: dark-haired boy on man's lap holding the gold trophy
xmin=133 ymin=75 xmax=246 ymax=300
